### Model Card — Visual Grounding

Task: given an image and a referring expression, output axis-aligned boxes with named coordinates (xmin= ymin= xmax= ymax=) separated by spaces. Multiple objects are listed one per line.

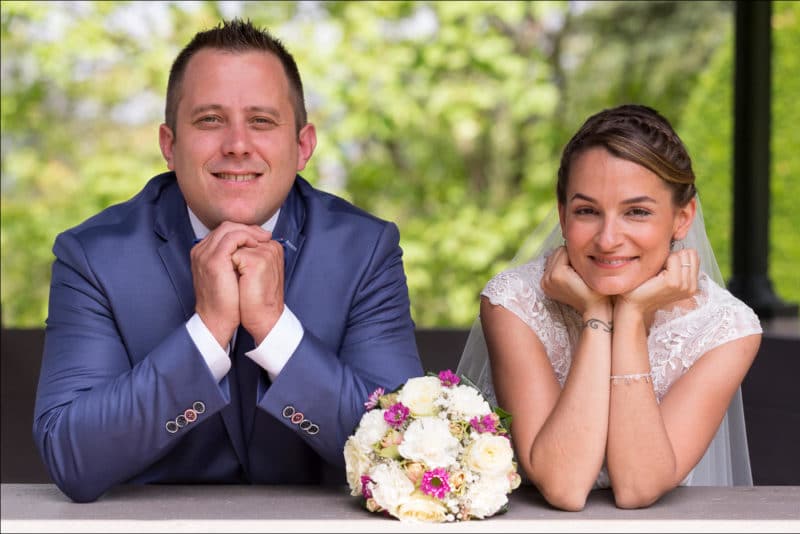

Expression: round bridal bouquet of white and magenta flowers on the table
xmin=344 ymin=370 xmax=521 ymax=522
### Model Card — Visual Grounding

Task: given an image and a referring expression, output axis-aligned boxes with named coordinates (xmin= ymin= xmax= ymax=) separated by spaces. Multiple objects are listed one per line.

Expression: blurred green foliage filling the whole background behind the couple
xmin=0 ymin=1 xmax=800 ymax=327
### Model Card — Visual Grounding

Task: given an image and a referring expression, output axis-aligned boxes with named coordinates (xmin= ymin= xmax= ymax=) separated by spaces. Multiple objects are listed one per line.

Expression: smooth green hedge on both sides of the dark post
xmin=681 ymin=2 xmax=800 ymax=303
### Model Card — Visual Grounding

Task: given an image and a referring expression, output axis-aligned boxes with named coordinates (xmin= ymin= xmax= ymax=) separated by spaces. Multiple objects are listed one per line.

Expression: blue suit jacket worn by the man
xmin=33 ymin=173 xmax=422 ymax=501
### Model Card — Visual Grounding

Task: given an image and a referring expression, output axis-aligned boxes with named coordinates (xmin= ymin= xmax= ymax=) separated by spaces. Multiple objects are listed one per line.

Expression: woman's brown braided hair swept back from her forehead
xmin=556 ymin=104 xmax=697 ymax=207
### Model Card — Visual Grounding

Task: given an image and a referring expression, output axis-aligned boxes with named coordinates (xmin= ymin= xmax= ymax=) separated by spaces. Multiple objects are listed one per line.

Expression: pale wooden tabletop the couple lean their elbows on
xmin=0 ymin=484 xmax=800 ymax=533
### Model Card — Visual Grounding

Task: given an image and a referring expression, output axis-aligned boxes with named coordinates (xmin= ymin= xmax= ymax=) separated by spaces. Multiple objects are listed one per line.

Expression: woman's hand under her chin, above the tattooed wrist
xmin=541 ymin=246 xmax=611 ymax=315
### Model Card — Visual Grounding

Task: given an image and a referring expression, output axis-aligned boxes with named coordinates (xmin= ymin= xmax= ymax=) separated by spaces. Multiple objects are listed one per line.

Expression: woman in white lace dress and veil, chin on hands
xmin=458 ymin=105 xmax=761 ymax=510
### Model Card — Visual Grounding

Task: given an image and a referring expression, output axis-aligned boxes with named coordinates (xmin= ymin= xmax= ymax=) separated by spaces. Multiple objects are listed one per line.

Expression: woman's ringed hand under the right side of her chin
xmin=614 ymin=249 xmax=700 ymax=316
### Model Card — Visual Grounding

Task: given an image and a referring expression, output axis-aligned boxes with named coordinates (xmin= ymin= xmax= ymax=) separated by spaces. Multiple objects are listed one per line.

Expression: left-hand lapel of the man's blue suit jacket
xmin=155 ymin=183 xmax=247 ymax=474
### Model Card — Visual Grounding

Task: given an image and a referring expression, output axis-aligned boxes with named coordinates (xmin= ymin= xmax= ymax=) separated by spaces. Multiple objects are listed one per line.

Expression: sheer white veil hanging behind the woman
xmin=456 ymin=196 xmax=753 ymax=486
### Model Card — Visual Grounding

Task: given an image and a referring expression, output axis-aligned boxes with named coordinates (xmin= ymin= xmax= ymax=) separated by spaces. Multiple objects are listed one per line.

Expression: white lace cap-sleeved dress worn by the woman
xmin=481 ymin=257 xmax=761 ymax=488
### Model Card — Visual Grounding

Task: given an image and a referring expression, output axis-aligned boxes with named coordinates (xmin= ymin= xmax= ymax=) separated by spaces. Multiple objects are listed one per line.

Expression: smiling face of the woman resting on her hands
xmin=559 ymin=147 xmax=693 ymax=295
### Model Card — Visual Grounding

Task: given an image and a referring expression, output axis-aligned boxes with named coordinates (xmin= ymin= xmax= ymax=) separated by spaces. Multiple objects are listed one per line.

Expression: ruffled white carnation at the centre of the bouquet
xmin=397 ymin=417 xmax=459 ymax=469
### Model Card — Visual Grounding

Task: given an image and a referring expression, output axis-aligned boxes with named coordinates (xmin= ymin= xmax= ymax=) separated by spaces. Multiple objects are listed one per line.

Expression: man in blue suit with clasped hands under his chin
xmin=33 ymin=16 xmax=422 ymax=502
